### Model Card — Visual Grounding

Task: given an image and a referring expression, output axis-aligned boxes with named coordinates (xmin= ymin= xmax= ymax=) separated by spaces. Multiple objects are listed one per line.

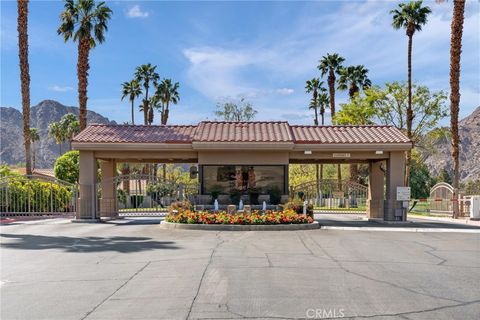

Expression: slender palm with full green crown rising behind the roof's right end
xmin=390 ymin=1 xmax=432 ymax=186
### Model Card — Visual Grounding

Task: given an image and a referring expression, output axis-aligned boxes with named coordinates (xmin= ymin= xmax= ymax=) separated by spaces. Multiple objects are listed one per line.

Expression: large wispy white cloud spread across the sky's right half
xmin=183 ymin=1 xmax=480 ymax=122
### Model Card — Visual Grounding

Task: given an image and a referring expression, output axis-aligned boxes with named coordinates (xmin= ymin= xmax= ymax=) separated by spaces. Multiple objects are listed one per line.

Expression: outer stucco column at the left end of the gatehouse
xmin=77 ymin=150 xmax=98 ymax=220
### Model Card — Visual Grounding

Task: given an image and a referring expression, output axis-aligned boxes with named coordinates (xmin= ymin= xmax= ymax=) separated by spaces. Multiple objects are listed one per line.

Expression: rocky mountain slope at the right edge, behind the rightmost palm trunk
xmin=425 ymin=107 xmax=480 ymax=181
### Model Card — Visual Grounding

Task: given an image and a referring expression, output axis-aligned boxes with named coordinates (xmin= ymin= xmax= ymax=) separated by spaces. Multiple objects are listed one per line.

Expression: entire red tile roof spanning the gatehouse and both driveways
xmin=73 ymin=121 xmax=410 ymax=144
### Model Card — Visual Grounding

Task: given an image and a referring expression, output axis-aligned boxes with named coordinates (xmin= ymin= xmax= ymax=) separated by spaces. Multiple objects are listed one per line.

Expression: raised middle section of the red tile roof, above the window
xmin=193 ymin=121 xmax=292 ymax=142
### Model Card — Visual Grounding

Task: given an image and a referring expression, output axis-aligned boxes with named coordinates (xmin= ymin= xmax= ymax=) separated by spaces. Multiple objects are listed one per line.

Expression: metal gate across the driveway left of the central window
xmin=96 ymin=174 xmax=198 ymax=217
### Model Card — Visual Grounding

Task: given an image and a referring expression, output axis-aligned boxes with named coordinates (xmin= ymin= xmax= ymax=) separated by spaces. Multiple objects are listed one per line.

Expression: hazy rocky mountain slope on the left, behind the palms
xmin=0 ymin=100 xmax=115 ymax=168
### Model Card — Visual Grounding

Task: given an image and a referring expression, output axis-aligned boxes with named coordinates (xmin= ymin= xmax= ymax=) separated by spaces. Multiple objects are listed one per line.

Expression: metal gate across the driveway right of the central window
xmin=290 ymin=179 xmax=368 ymax=212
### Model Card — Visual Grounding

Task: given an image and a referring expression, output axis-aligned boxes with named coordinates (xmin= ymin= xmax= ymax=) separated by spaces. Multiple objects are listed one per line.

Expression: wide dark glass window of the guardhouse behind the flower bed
xmin=202 ymin=165 xmax=286 ymax=194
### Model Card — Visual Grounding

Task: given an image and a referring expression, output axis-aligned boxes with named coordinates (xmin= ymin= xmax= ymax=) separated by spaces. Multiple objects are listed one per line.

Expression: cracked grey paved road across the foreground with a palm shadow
xmin=0 ymin=220 xmax=480 ymax=320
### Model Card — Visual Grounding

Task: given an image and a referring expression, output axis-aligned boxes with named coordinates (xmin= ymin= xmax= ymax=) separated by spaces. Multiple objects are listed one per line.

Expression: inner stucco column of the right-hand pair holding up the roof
xmin=367 ymin=161 xmax=385 ymax=219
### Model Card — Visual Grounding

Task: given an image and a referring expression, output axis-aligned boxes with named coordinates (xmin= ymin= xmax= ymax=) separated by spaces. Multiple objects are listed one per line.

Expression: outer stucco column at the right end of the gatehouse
xmin=384 ymin=151 xmax=405 ymax=221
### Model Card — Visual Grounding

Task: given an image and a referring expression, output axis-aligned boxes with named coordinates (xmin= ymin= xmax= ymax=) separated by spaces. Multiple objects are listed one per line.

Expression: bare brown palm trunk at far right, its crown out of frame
xmin=450 ymin=0 xmax=465 ymax=218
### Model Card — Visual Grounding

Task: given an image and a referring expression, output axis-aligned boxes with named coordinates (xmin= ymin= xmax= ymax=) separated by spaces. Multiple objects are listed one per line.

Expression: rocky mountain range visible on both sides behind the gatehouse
xmin=0 ymin=100 xmax=480 ymax=181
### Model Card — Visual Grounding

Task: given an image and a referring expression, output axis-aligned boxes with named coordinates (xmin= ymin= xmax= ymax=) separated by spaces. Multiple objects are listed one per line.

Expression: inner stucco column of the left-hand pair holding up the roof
xmin=100 ymin=160 xmax=118 ymax=218
